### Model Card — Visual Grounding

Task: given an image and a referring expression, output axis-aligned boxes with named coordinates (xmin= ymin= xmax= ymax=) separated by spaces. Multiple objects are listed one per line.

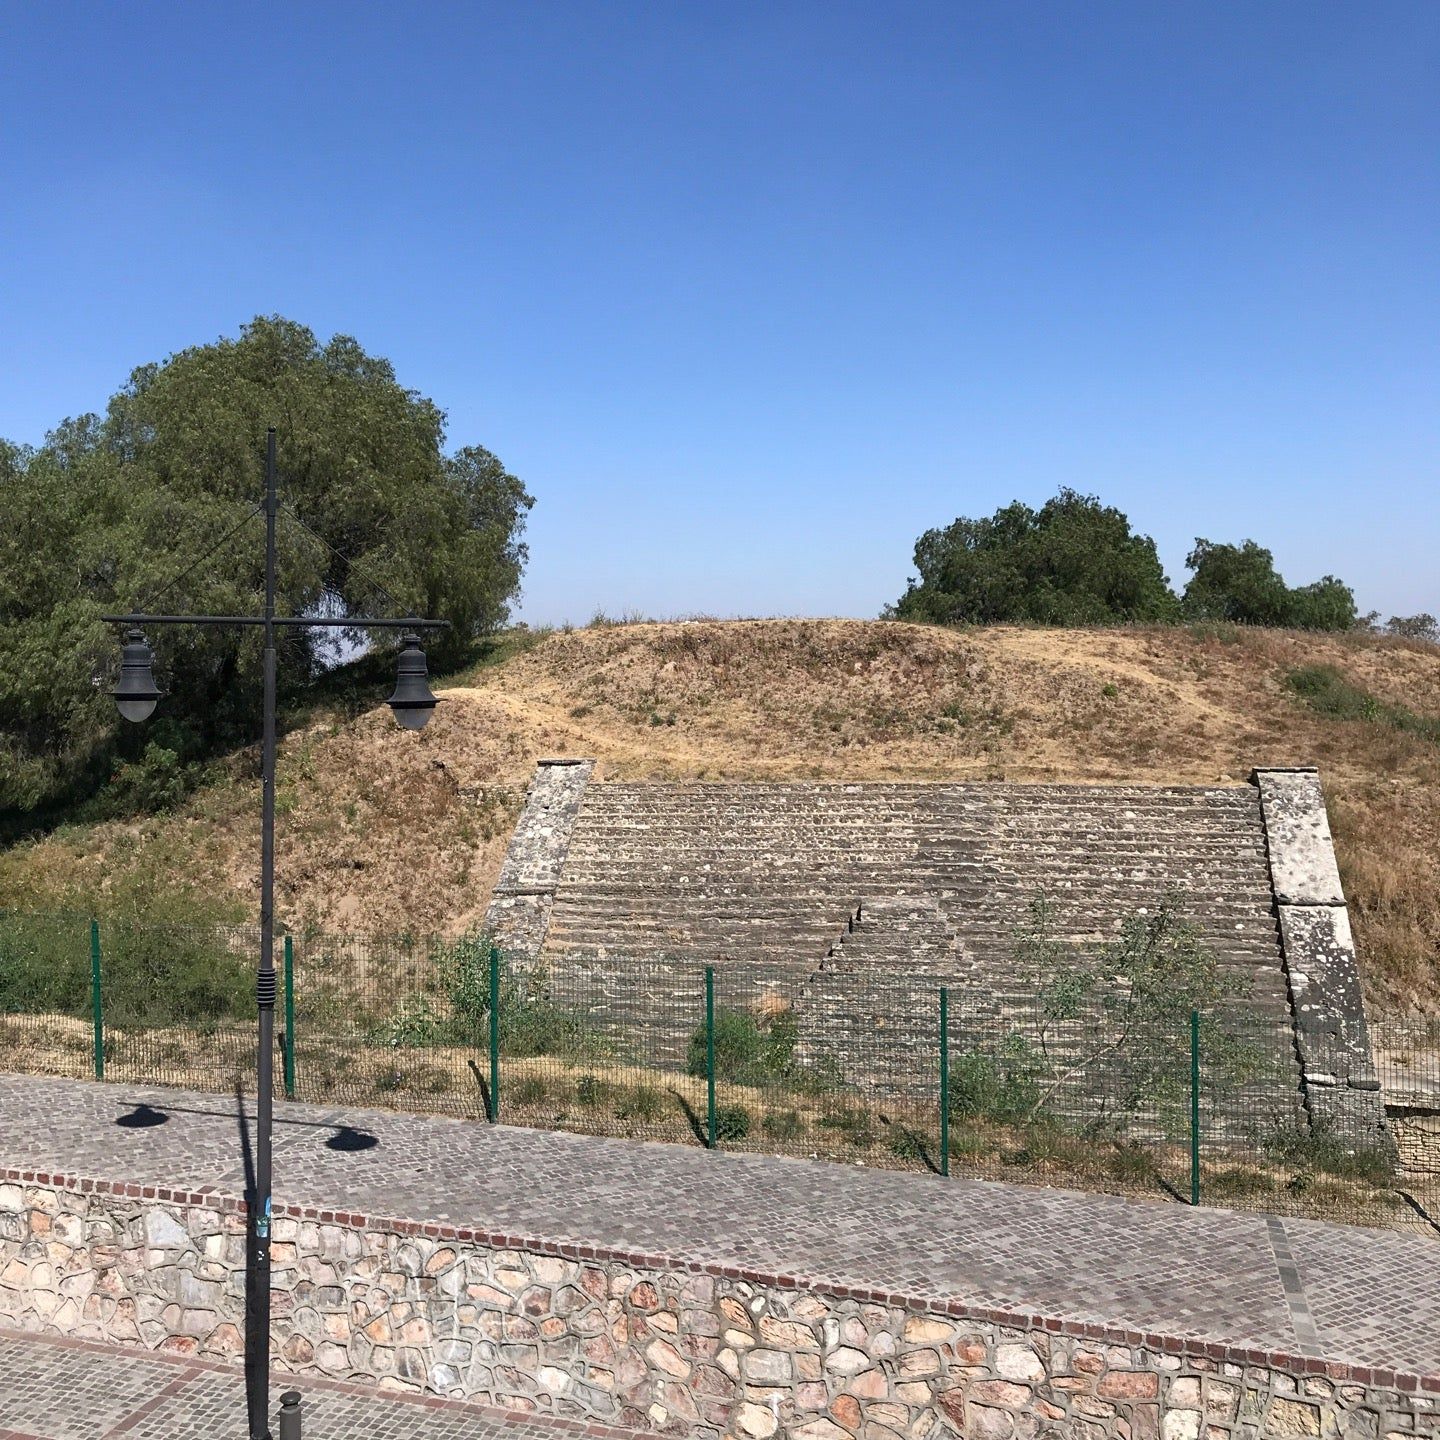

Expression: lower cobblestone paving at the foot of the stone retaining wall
xmin=0 ymin=1331 xmax=648 ymax=1440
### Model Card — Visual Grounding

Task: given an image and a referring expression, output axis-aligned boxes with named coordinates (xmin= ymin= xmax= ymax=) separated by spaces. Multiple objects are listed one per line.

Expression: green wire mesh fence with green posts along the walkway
xmin=0 ymin=912 xmax=1440 ymax=1234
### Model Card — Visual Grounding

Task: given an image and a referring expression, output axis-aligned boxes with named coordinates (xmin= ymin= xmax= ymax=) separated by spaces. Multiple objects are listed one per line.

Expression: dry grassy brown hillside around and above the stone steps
xmin=0 ymin=621 xmax=1440 ymax=1009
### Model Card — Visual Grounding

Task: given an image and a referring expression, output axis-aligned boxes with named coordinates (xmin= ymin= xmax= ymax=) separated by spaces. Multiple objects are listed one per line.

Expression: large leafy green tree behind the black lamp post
xmin=0 ymin=317 xmax=533 ymax=814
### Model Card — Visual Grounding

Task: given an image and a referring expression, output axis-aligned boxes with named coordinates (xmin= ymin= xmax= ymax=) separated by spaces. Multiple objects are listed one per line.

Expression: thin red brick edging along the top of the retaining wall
xmin=0 ymin=1168 xmax=1440 ymax=1394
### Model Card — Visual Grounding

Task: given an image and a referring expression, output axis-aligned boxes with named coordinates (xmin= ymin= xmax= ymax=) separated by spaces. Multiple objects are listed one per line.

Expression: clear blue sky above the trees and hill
xmin=0 ymin=0 xmax=1440 ymax=621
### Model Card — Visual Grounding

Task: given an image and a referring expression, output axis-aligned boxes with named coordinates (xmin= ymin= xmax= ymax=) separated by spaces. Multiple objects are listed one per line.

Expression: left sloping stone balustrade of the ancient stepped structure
xmin=485 ymin=760 xmax=595 ymax=960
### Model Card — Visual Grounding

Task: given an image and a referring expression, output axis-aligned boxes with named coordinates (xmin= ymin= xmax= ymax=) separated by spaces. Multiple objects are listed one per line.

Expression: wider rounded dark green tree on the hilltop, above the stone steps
xmin=887 ymin=490 xmax=1176 ymax=625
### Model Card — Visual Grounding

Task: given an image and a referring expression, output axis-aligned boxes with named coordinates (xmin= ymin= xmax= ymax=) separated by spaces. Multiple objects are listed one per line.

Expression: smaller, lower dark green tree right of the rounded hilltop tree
xmin=1181 ymin=540 xmax=1359 ymax=631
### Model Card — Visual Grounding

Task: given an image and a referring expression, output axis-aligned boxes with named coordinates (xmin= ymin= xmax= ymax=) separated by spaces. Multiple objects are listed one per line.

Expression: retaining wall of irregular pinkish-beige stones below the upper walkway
xmin=0 ymin=1172 xmax=1440 ymax=1440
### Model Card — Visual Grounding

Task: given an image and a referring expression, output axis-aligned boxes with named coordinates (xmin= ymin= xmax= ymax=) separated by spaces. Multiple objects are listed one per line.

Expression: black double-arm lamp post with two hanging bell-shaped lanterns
xmin=102 ymin=429 xmax=449 ymax=1440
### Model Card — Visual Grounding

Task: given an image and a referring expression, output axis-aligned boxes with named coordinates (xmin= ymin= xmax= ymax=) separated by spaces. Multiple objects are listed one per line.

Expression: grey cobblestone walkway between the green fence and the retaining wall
xmin=0 ymin=1076 xmax=1440 ymax=1375
